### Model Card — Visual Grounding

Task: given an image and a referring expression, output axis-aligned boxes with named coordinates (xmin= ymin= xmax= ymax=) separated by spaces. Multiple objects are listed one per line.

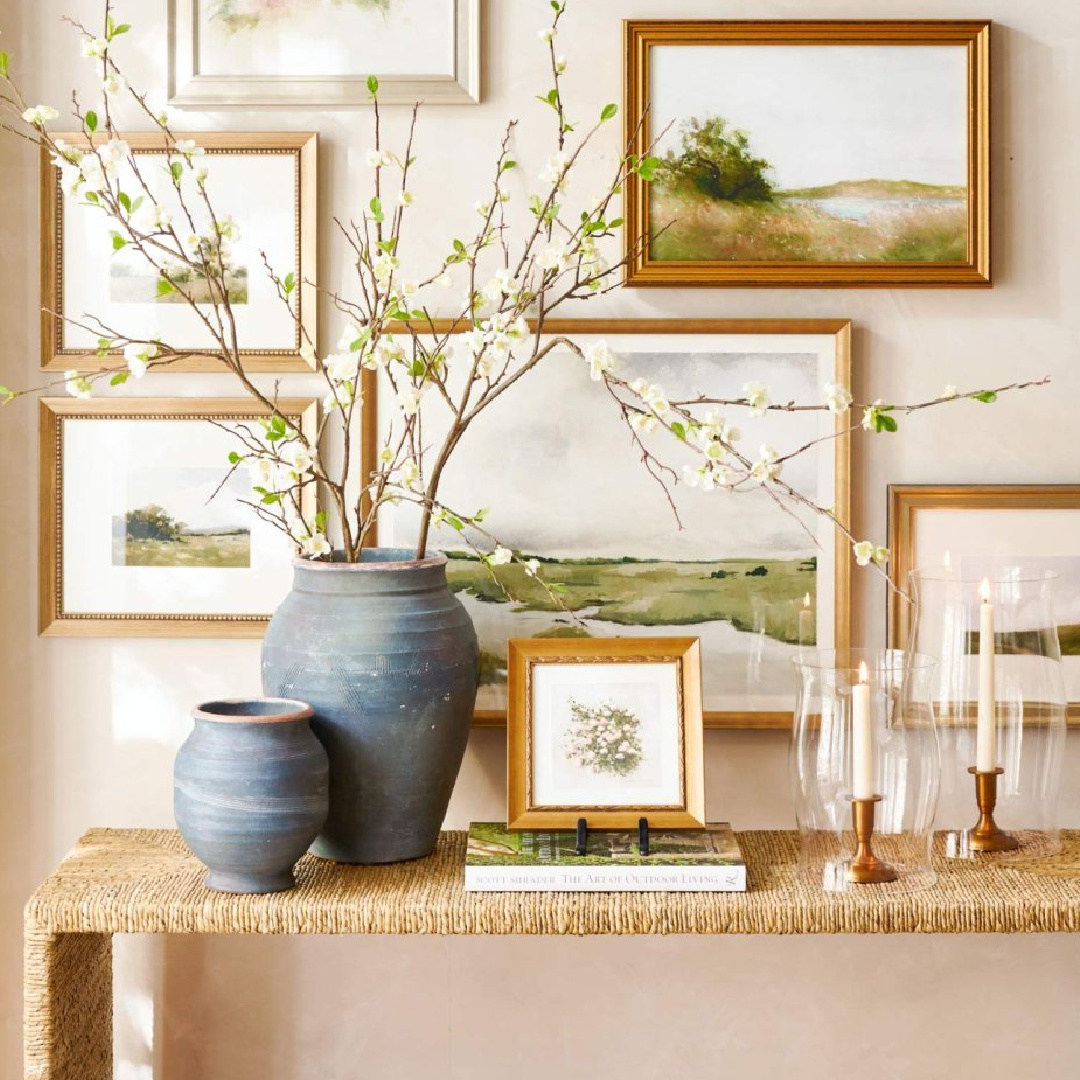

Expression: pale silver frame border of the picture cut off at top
xmin=168 ymin=0 xmax=484 ymax=110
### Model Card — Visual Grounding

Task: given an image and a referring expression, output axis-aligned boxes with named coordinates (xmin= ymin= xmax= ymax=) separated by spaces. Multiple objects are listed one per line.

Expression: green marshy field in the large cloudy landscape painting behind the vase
xmin=447 ymin=553 xmax=816 ymax=685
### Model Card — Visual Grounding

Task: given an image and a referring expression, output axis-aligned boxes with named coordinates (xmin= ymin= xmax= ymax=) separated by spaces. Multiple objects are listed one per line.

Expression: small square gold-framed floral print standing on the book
xmin=507 ymin=637 xmax=705 ymax=828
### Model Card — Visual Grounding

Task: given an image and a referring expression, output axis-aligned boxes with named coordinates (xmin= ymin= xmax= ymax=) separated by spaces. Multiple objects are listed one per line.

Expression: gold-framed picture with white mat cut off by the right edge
xmin=888 ymin=484 xmax=1080 ymax=724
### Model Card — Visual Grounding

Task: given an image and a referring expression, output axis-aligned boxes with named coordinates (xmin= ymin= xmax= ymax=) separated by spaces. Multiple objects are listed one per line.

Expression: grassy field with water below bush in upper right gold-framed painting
xmin=649 ymin=180 xmax=968 ymax=262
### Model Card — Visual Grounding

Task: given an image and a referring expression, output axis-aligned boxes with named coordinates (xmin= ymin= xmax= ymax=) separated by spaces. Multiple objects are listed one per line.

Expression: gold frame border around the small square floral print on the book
xmin=507 ymin=635 xmax=705 ymax=829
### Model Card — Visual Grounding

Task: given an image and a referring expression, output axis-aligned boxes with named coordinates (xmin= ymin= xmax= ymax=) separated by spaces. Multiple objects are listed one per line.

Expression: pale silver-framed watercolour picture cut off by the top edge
xmin=168 ymin=0 xmax=481 ymax=109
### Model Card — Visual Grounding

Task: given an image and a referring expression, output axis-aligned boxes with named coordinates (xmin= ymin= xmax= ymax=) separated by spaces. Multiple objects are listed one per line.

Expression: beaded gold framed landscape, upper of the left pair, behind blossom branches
xmin=41 ymin=132 xmax=319 ymax=372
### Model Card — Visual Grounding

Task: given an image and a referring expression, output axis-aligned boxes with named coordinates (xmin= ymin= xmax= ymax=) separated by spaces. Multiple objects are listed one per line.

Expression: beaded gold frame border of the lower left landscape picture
xmin=38 ymin=397 xmax=319 ymax=638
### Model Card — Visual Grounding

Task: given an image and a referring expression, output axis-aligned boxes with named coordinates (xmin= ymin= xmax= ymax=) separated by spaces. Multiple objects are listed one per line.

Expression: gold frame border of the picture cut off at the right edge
xmin=887 ymin=484 xmax=1080 ymax=727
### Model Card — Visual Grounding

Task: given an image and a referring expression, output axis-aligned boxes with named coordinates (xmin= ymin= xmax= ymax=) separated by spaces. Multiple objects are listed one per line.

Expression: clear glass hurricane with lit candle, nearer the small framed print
xmin=791 ymin=649 xmax=939 ymax=894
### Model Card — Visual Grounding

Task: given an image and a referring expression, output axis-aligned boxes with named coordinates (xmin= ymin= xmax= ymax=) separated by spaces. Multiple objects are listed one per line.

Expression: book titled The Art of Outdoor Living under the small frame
xmin=465 ymin=822 xmax=746 ymax=892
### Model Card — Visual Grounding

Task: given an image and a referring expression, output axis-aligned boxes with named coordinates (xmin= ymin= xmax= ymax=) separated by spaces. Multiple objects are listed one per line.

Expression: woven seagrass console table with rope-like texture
xmin=24 ymin=829 xmax=1080 ymax=1080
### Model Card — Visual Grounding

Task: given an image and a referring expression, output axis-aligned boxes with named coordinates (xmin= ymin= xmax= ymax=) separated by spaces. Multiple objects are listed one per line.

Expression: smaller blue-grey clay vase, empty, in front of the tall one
xmin=173 ymin=698 xmax=328 ymax=892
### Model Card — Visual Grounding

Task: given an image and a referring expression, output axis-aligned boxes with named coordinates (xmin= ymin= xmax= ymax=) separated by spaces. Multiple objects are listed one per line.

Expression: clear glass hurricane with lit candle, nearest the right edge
xmin=910 ymin=561 xmax=1066 ymax=860
